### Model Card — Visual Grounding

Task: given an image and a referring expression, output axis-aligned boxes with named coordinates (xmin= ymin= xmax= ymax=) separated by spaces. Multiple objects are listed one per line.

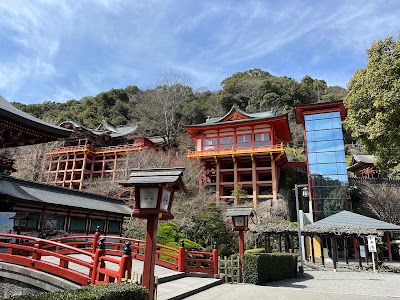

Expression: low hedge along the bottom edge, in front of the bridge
xmin=10 ymin=283 xmax=148 ymax=300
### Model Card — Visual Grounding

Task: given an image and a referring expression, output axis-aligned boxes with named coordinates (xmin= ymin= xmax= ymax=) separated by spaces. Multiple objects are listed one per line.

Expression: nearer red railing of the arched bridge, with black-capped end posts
xmin=0 ymin=233 xmax=136 ymax=285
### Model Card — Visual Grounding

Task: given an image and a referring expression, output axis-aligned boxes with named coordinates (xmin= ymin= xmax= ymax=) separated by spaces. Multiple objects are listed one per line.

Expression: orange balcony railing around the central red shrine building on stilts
xmin=187 ymin=143 xmax=284 ymax=158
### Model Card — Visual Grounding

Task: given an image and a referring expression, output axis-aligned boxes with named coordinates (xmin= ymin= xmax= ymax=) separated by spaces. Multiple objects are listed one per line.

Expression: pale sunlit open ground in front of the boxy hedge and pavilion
xmin=186 ymin=271 xmax=400 ymax=300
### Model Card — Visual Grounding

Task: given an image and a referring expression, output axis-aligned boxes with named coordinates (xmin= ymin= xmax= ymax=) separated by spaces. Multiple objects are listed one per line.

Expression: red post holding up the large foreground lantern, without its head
xmin=142 ymin=216 xmax=158 ymax=300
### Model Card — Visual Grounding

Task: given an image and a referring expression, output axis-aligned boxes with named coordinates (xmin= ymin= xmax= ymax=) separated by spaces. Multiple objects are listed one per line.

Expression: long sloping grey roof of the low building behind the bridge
xmin=0 ymin=176 xmax=132 ymax=215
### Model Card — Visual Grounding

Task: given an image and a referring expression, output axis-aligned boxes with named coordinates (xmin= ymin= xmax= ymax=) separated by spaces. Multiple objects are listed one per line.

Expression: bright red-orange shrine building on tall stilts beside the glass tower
xmin=185 ymin=106 xmax=291 ymax=206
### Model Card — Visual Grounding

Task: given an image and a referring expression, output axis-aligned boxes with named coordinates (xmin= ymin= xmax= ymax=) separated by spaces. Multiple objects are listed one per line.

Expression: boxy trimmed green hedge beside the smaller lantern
xmin=243 ymin=253 xmax=297 ymax=284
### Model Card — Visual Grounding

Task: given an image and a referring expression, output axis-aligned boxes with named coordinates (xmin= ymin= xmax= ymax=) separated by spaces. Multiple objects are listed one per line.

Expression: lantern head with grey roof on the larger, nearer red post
xmin=121 ymin=168 xmax=186 ymax=220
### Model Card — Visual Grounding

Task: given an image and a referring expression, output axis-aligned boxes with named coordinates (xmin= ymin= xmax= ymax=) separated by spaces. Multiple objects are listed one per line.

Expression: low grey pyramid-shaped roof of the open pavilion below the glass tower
xmin=306 ymin=210 xmax=400 ymax=231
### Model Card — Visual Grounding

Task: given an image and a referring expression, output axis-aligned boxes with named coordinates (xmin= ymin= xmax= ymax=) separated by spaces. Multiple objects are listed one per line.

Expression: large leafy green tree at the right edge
xmin=344 ymin=37 xmax=400 ymax=167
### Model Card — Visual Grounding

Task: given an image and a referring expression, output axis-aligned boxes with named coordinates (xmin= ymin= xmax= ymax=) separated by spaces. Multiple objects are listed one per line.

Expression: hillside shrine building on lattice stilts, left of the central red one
xmin=42 ymin=120 xmax=158 ymax=190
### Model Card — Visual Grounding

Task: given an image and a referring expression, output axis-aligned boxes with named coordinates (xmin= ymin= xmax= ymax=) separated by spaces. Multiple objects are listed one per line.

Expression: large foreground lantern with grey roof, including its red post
xmin=122 ymin=168 xmax=185 ymax=300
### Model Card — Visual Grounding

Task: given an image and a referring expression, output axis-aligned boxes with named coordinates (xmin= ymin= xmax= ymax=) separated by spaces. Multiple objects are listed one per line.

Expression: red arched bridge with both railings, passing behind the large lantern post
xmin=0 ymin=233 xmax=218 ymax=285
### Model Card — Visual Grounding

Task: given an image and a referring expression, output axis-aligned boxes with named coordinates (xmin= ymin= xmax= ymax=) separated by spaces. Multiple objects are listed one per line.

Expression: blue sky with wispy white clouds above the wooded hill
xmin=0 ymin=0 xmax=400 ymax=103
